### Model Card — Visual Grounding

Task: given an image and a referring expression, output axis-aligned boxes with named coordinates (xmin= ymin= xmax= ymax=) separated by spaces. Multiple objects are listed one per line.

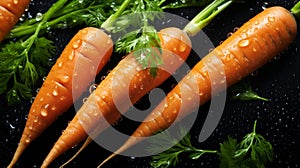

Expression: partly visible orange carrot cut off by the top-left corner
xmin=0 ymin=0 xmax=30 ymax=42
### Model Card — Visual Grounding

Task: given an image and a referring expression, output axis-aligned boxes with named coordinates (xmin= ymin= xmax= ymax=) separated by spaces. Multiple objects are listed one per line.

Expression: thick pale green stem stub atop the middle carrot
xmin=183 ymin=0 xmax=233 ymax=36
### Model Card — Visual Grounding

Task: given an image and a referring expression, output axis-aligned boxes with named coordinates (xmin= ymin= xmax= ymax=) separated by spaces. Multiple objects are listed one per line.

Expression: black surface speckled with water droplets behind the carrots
xmin=0 ymin=0 xmax=300 ymax=168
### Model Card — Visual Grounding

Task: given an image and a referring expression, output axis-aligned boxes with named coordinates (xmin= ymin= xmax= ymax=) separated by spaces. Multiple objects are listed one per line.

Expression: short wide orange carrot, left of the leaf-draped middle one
xmin=8 ymin=27 xmax=113 ymax=167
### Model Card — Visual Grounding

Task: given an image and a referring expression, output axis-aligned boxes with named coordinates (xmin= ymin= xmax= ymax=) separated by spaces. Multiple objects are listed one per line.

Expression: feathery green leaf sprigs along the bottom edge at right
xmin=149 ymin=121 xmax=273 ymax=168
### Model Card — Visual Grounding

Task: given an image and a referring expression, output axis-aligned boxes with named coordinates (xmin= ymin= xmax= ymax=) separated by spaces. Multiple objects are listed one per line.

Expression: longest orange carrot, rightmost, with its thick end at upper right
xmin=99 ymin=7 xmax=297 ymax=167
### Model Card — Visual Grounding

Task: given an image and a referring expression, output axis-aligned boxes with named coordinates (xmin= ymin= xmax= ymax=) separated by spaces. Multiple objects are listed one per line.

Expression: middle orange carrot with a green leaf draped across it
xmin=42 ymin=28 xmax=191 ymax=167
